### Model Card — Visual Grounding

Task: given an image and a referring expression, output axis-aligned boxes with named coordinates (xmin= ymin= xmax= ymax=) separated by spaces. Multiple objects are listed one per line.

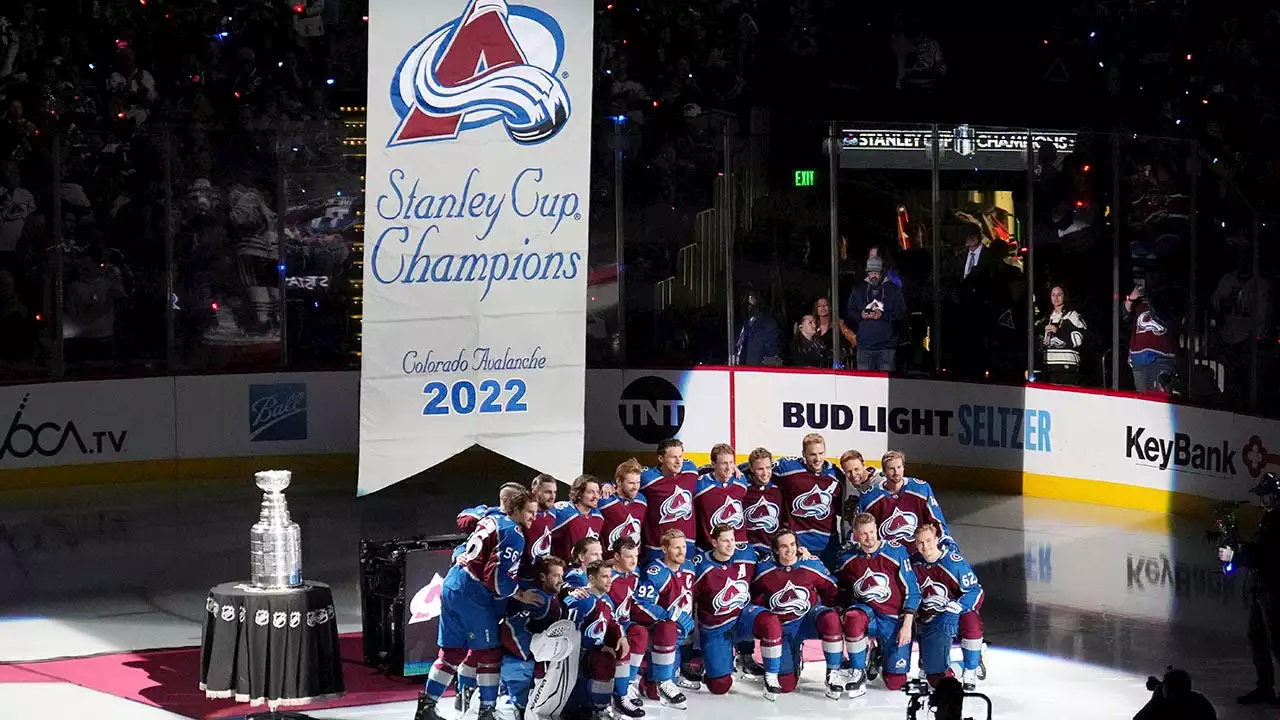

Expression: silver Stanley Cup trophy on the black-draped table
xmin=250 ymin=470 xmax=302 ymax=591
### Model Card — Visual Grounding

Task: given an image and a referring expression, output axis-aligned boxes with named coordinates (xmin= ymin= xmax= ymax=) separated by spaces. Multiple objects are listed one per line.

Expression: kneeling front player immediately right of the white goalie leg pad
xmin=564 ymin=560 xmax=634 ymax=720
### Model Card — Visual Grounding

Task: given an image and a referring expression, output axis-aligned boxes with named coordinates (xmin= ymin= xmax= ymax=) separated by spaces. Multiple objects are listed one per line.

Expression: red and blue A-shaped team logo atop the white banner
xmin=387 ymin=0 xmax=570 ymax=147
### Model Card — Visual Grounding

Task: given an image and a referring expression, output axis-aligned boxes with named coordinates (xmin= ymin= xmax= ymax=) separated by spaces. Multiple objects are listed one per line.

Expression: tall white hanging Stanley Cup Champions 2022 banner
xmin=358 ymin=0 xmax=593 ymax=495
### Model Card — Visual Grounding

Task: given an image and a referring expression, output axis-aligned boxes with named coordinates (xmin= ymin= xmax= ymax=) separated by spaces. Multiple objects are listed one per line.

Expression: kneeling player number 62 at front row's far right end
xmin=913 ymin=523 xmax=983 ymax=691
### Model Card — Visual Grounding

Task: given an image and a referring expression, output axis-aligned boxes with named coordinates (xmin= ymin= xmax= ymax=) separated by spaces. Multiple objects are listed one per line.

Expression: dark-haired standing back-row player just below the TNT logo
xmin=640 ymin=439 xmax=698 ymax=562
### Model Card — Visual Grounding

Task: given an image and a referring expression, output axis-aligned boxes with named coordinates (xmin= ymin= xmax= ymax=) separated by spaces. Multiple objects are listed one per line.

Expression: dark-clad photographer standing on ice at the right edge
xmin=1217 ymin=473 xmax=1280 ymax=705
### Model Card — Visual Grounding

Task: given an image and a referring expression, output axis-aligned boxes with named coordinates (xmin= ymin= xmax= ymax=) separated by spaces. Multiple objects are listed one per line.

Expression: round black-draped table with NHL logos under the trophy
xmin=200 ymin=582 xmax=346 ymax=711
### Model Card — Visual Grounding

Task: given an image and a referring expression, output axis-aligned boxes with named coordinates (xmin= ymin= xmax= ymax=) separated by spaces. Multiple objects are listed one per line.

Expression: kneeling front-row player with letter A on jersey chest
xmin=694 ymin=525 xmax=782 ymax=700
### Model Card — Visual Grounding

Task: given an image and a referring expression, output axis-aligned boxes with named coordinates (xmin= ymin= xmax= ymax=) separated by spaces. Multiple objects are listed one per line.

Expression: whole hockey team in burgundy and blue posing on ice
xmin=415 ymin=433 xmax=986 ymax=720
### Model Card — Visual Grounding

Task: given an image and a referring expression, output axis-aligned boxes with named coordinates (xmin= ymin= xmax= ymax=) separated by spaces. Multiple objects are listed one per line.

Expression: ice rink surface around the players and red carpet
xmin=0 ymin=475 xmax=1277 ymax=720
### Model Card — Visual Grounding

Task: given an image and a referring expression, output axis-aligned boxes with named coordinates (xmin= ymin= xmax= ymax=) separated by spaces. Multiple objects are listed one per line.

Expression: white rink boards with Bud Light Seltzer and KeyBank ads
xmin=0 ymin=368 xmax=1280 ymax=511
